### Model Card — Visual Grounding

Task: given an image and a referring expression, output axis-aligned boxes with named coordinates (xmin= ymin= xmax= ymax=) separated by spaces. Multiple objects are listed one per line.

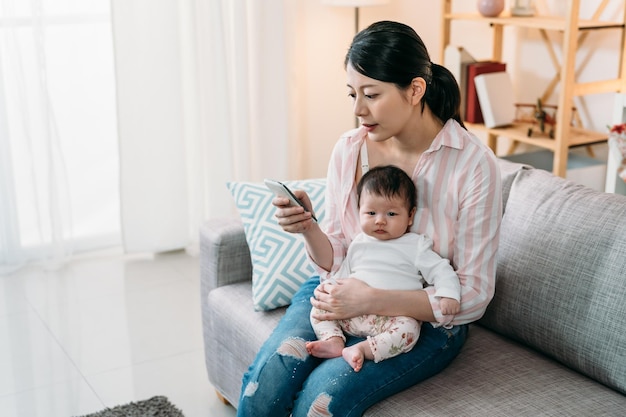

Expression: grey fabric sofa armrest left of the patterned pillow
xmin=200 ymin=218 xmax=252 ymax=300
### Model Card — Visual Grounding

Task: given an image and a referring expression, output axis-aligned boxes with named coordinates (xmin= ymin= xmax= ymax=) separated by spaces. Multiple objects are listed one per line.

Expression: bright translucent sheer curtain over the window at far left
xmin=0 ymin=0 xmax=119 ymax=273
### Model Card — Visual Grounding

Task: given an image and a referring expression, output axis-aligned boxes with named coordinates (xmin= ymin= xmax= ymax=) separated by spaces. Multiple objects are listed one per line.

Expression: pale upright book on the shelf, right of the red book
xmin=474 ymin=71 xmax=515 ymax=128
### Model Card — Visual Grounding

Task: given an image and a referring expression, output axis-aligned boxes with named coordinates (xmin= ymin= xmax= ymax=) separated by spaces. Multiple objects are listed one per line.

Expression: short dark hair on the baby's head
xmin=356 ymin=165 xmax=417 ymax=212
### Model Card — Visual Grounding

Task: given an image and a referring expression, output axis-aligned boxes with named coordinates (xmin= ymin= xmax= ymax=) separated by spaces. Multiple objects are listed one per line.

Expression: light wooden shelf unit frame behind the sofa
xmin=440 ymin=0 xmax=626 ymax=177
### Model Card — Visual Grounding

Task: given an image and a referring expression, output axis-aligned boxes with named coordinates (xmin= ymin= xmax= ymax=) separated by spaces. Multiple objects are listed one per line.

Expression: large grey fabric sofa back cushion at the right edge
xmin=480 ymin=163 xmax=626 ymax=393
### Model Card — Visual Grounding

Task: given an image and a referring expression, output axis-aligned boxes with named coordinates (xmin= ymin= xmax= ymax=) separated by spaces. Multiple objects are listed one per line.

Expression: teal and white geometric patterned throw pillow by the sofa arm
xmin=227 ymin=179 xmax=326 ymax=311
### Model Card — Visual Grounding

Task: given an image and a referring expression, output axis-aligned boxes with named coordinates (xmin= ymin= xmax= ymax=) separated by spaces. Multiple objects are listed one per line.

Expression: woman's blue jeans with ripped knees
xmin=237 ymin=277 xmax=467 ymax=417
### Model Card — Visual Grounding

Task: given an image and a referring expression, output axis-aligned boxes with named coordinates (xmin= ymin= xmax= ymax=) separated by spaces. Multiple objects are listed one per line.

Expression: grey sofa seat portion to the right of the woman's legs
xmin=365 ymin=325 xmax=626 ymax=417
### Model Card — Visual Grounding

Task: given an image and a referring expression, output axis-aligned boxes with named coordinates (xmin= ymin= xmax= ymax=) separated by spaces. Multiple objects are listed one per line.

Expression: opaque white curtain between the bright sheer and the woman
xmin=112 ymin=0 xmax=293 ymax=252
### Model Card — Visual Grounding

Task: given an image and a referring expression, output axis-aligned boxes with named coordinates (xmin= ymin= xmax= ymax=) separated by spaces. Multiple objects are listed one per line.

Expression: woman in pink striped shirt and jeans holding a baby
xmin=238 ymin=22 xmax=502 ymax=417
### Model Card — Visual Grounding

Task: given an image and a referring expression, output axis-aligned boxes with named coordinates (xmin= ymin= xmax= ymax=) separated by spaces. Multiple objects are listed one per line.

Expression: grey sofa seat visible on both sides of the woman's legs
xmin=203 ymin=282 xmax=626 ymax=417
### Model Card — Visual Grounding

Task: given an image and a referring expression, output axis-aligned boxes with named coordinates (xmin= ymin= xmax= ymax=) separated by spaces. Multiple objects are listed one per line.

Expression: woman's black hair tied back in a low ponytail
xmin=344 ymin=21 xmax=465 ymax=127
